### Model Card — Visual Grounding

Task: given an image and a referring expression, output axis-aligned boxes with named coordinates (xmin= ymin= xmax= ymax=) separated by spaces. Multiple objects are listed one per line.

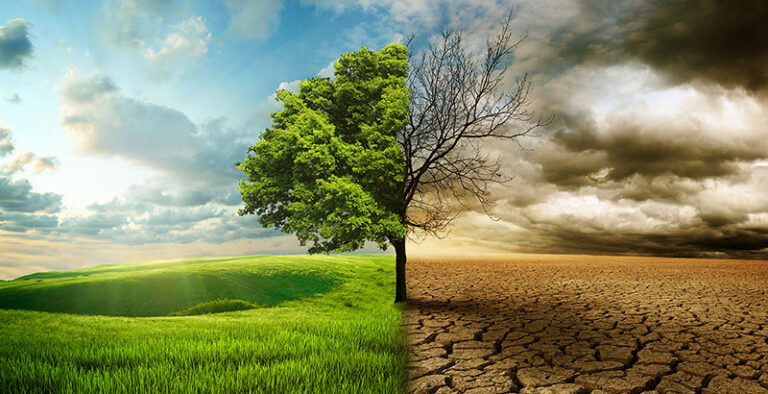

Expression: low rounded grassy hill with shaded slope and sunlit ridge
xmin=0 ymin=256 xmax=341 ymax=316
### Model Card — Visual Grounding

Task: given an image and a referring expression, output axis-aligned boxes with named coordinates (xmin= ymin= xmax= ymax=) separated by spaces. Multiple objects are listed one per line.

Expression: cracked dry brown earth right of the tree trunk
xmin=404 ymin=256 xmax=768 ymax=394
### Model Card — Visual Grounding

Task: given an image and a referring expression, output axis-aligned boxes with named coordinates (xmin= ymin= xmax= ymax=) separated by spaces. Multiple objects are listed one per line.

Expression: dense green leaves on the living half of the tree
xmin=238 ymin=44 xmax=410 ymax=253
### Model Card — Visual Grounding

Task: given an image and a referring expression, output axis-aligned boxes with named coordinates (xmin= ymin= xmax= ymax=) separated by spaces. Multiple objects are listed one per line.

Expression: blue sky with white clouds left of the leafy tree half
xmin=0 ymin=0 xmax=462 ymax=278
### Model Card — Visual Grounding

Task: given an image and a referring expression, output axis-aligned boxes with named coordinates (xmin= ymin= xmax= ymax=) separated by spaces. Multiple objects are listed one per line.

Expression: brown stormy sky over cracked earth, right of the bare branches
xmin=448 ymin=0 xmax=768 ymax=258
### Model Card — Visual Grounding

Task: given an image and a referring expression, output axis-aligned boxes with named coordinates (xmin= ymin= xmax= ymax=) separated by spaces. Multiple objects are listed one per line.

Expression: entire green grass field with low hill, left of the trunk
xmin=0 ymin=255 xmax=406 ymax=393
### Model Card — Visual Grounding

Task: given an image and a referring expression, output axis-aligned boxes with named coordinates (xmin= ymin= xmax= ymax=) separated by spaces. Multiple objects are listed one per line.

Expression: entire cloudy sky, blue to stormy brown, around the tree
xmin=0 ymin=0 xmax=768 ymax=279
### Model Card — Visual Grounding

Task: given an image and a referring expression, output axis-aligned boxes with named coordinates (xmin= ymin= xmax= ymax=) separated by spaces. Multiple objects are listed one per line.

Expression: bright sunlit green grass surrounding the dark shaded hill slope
xmin=0 ymin=255 xmax=406 ymax=393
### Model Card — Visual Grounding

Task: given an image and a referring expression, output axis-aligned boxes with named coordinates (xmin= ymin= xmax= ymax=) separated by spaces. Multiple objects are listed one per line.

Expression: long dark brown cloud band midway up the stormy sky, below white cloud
xmin=539 ymin=124 xmax=768 ymax=186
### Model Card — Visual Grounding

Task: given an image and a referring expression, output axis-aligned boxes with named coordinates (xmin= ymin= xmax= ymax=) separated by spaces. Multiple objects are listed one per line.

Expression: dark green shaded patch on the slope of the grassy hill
xmin=0 ymin=271 xmax=338 ymax=317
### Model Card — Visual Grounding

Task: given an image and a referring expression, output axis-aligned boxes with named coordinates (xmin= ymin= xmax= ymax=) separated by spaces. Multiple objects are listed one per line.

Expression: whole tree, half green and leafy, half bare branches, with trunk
xmin=238 ymin=13 xmax=545 ymax=302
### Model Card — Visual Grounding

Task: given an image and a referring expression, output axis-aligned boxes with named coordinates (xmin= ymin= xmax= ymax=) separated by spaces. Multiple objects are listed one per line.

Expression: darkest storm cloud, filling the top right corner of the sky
xmin=624 ymin=0 xmax=768 ymax=91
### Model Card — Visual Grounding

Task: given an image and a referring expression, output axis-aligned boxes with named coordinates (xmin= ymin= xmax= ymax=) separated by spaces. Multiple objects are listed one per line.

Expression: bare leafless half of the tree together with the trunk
xmin=392 ymin=12 xmax=549 ymax=301
